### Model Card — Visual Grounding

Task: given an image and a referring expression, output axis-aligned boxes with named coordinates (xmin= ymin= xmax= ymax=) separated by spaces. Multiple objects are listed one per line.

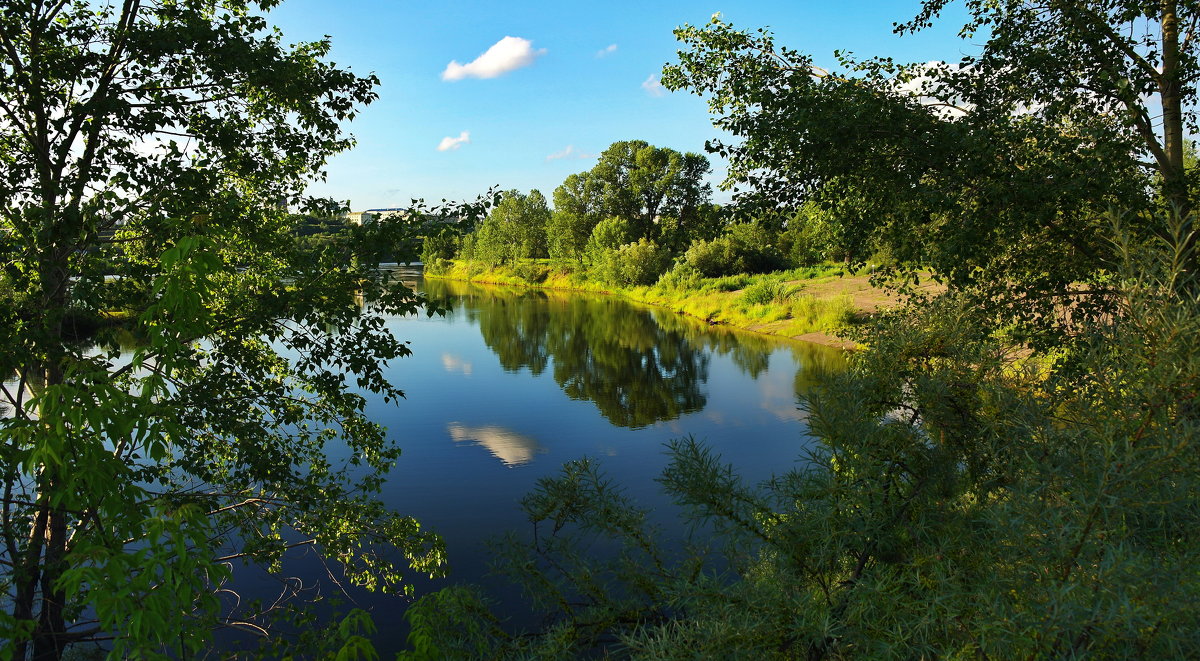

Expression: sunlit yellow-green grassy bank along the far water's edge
xmin=426 ymin=260 xmax=930 ymax=349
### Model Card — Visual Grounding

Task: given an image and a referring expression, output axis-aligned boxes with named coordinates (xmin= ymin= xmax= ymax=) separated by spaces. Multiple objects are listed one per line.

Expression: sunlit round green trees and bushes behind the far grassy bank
xmin=421 ymin=140 xmax=864 ymax=286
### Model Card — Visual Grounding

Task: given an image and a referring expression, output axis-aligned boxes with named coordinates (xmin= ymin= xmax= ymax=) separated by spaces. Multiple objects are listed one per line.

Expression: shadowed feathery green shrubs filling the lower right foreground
xmin=403 ymin=219 xmax=1200 ymax=659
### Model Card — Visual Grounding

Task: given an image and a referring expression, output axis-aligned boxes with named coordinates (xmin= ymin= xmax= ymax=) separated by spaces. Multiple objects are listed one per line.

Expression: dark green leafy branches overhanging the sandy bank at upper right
xmin=662 ymin=9 xmax=1166 ymax=324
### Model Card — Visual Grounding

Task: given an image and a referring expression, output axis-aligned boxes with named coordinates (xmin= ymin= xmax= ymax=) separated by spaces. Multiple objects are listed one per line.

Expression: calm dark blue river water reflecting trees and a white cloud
xmin=236 ymin=272 xmax=842 ymax=657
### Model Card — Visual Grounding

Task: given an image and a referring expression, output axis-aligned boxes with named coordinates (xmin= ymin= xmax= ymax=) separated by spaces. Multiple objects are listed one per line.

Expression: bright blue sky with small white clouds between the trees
xmin=268 ymin=0 xmax=973 ymax=210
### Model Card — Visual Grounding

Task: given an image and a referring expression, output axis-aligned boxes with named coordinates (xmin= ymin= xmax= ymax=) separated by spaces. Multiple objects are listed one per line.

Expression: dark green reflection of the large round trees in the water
xmin=425 ymin=281 xmax=705 ymax=428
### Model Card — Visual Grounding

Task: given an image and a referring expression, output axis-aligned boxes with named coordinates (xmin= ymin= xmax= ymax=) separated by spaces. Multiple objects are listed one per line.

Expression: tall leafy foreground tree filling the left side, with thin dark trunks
xmin=0 ymin=0 xmax=443 ymax=659
